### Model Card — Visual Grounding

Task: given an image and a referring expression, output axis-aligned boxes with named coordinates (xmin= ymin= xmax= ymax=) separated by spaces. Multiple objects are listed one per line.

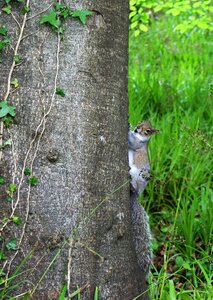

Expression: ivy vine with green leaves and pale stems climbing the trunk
xmin=0 ymin=0 xmax=93 ymax=292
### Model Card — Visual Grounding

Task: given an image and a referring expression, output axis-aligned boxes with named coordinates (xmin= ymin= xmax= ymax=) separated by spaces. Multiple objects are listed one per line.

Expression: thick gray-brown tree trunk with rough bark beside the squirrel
xmin=0 ymin=0 xmax=148 ymax=299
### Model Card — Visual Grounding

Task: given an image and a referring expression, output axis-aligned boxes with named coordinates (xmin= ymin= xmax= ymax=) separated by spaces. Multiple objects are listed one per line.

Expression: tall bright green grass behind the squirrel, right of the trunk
xmin=129 ymin=16 xmax=213 ymax=300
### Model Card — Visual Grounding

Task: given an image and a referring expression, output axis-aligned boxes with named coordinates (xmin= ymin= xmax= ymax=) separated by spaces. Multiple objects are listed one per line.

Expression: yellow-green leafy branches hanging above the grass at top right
xmin=129 ymin=0 xmax=213 ymax=36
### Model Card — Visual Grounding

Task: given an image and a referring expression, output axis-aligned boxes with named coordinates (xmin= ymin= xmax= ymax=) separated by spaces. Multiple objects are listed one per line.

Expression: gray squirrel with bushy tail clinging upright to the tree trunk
xmin=128 ymin=121 xmax=159 ymax=276
